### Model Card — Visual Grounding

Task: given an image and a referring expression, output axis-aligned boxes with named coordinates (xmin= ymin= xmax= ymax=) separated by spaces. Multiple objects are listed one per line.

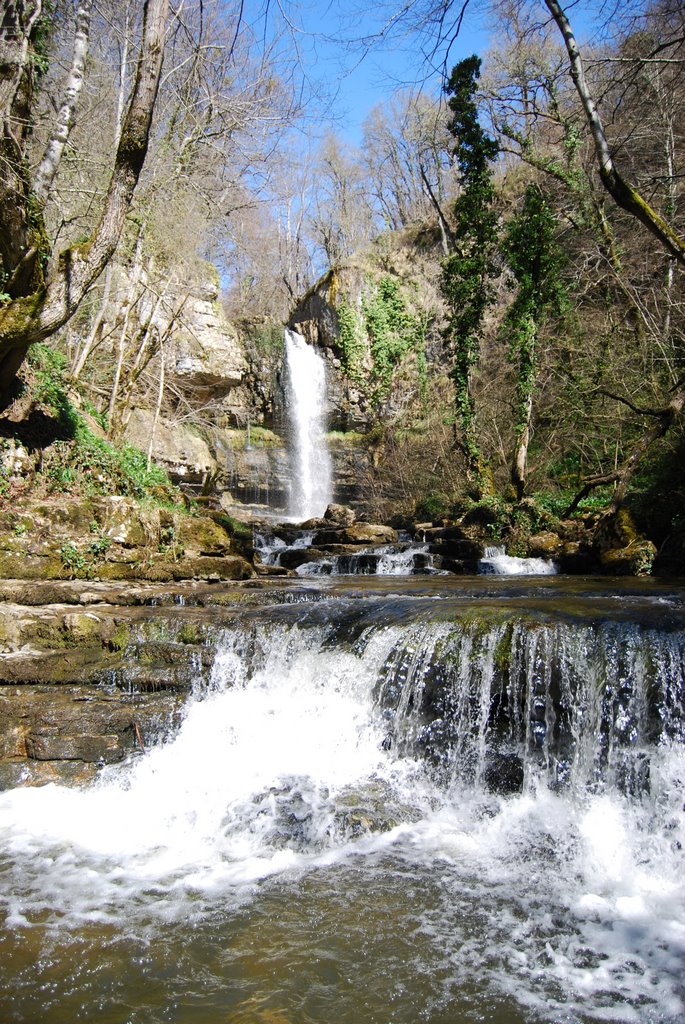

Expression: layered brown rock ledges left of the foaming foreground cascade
xmin=0 ymin=582 xmax=250 ymax=788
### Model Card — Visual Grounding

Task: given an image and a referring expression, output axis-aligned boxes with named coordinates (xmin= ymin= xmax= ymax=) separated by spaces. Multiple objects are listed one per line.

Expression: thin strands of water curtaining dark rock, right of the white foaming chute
xmin=378 ymin=621 xmax=685 ymax=796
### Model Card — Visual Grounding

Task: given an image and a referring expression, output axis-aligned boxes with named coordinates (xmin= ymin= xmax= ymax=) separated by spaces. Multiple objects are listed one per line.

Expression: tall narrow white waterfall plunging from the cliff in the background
xmin=286 ymin=329 xmax=333 ymax=521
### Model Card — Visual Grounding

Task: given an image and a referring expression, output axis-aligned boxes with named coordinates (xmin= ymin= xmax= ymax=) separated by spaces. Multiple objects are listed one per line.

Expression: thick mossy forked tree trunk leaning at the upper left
xmin=0 ymin=0 xmax=169 ymax=408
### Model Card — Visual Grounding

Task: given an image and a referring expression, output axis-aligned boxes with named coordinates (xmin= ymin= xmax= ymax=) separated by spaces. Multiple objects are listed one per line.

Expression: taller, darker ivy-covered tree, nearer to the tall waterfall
xmin=441 ymin=56 xmax=498 ymax=494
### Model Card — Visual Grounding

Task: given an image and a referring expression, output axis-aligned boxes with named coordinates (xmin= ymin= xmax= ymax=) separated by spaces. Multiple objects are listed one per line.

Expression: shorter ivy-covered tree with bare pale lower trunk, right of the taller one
xmin=502 ymin=184 xmax=565 ymax=500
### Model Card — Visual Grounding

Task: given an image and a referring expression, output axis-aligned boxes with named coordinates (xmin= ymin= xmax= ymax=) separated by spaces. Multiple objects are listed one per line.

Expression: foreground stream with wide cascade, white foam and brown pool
xmin=0 ymin=577 xmax=685 ymax=1024
